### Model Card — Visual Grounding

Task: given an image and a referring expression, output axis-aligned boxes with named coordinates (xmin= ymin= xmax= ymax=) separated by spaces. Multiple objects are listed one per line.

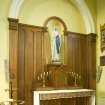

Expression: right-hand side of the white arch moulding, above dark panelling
xmin=71 ymin=0 xmax=95 ymax=33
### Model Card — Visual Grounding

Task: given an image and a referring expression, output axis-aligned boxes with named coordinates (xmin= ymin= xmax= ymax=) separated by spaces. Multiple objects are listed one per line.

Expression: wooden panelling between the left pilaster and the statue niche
xmin=18 ymin=24 xmax=44 ymax=105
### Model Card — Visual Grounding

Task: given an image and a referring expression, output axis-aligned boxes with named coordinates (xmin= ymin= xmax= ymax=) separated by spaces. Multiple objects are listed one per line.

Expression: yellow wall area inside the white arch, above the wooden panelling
xmin=18 ymin=0 xmax=86 ymax=33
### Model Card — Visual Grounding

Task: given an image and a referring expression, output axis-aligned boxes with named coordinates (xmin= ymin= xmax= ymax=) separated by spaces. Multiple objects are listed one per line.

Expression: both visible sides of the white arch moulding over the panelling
xmin=9 ymin=0 xmax=95 ymax=33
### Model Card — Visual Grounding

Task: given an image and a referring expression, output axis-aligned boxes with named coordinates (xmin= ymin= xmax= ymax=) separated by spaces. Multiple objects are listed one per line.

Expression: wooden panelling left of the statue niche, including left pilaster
xmin=9 ymin=19 xmax=45 ymax=105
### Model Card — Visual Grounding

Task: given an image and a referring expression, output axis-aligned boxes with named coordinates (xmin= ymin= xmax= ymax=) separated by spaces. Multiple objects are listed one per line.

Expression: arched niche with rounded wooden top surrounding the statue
xmin=44 ymin=16 xmax=67 ymax=63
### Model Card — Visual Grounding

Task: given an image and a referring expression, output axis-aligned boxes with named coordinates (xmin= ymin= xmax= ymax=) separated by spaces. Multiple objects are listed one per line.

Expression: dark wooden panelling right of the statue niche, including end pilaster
xmin=65 ymin=32 xmax=96 ymax=89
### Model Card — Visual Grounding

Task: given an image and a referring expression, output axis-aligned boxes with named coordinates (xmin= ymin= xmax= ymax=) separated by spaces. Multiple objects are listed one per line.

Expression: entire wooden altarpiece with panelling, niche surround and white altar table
xmin=8 ymin=17 xmax=96 ymax=105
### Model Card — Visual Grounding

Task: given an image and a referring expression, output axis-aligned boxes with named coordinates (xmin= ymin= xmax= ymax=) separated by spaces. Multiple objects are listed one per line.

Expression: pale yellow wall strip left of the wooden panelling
xmin=0 ymin=0 xmax=11 ymax=99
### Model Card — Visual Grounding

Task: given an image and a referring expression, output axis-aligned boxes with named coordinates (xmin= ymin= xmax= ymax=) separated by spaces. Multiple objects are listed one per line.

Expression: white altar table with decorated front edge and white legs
xmin=33 ymin=89 xmax=95 ymax=105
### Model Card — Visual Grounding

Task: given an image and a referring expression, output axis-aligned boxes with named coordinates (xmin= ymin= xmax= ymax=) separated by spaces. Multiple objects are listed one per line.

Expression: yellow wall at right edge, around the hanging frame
xmin=97 ymin=0 xmax=105 ymax=105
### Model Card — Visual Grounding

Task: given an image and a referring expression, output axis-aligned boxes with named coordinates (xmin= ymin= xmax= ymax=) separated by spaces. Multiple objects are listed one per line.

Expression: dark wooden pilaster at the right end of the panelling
xmin=87 ymin=33 xmax=96 ymax=89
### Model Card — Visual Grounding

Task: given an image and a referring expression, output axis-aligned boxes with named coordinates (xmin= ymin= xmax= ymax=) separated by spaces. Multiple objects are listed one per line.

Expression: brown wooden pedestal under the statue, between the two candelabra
xmin=47 ymin=62 xmax=67 ymax=87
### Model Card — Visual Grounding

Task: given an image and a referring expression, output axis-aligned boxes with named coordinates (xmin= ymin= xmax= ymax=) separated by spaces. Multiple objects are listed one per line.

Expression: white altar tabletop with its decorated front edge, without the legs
xmin=34 ymin=89 xmax=95 ymax=100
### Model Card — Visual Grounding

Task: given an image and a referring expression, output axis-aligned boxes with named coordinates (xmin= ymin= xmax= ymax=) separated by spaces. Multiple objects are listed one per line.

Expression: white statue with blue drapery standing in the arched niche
xmin=51 ymin=28 xmax=61 ymax=61
